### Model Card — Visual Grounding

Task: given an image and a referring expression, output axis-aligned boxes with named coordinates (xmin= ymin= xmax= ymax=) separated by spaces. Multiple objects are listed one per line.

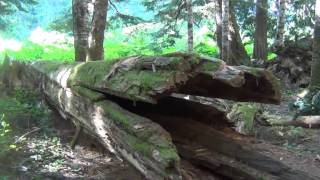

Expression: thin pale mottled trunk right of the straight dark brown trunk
xmin=275 ymin=0 xmax=286 ymax=47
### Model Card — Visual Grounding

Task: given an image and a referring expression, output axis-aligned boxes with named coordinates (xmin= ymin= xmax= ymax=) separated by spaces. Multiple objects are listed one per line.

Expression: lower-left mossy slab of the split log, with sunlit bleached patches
xmin=6 ymin=62 xmax=181 ymax=179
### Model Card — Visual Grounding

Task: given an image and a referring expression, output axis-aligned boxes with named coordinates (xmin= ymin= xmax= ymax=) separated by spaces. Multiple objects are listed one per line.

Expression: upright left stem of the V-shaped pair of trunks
xmin=72 ymin=0 xmax=91 ymax=61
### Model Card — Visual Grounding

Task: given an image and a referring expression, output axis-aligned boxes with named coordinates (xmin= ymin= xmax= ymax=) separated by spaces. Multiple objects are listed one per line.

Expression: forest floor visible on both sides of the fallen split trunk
xmin=0 ymin=87 xmax=320 ymax=180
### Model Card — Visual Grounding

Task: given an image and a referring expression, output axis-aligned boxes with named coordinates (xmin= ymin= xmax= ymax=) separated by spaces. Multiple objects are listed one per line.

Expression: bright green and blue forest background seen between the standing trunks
xmin=0 ymin=0 xmax=314 ymax=60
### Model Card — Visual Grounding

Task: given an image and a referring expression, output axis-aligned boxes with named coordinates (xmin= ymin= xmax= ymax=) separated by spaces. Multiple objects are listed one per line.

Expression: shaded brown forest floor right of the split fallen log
xmin=254 ymin=89 xmax=320 ymax=178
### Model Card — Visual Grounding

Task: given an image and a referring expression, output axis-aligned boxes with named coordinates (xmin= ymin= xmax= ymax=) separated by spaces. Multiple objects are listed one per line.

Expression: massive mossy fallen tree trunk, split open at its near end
xmin=4 ymin=53 xmax=314 ymax=179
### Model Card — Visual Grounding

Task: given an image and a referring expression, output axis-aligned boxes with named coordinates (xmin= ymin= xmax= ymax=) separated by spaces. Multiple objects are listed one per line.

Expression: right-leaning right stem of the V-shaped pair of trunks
xmin=89 ymin=0 xmax=108 ymax=60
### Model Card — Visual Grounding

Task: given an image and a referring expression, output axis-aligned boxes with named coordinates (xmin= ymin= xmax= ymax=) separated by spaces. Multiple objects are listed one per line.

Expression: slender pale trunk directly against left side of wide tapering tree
xmin=221 ymin=0 xmax=230 ymax=63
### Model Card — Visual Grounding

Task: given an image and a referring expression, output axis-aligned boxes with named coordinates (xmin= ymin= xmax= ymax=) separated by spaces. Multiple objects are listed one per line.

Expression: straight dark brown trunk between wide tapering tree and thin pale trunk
xmin=253 ymin=0 xmax=268 ymax=60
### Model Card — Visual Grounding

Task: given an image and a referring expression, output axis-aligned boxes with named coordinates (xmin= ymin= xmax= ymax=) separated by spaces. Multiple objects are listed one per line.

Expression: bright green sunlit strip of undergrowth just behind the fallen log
xmin=0 ymin=41 xmax=276 ymax=62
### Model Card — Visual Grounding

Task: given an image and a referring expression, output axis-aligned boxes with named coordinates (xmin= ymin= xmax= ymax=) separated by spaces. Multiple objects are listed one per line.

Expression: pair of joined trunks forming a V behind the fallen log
xmin=72 ymin=0 xmax=108 ymax=61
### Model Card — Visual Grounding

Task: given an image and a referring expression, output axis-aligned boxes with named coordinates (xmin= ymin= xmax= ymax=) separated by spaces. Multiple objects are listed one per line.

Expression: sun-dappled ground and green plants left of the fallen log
xmin=0 ymin=89 xmax=139 ymax=179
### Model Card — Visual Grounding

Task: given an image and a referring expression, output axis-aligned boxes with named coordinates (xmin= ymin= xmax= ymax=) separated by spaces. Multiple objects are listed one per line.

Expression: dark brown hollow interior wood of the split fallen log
xmin=104 ymin=93 xmax=317 ymax=180
